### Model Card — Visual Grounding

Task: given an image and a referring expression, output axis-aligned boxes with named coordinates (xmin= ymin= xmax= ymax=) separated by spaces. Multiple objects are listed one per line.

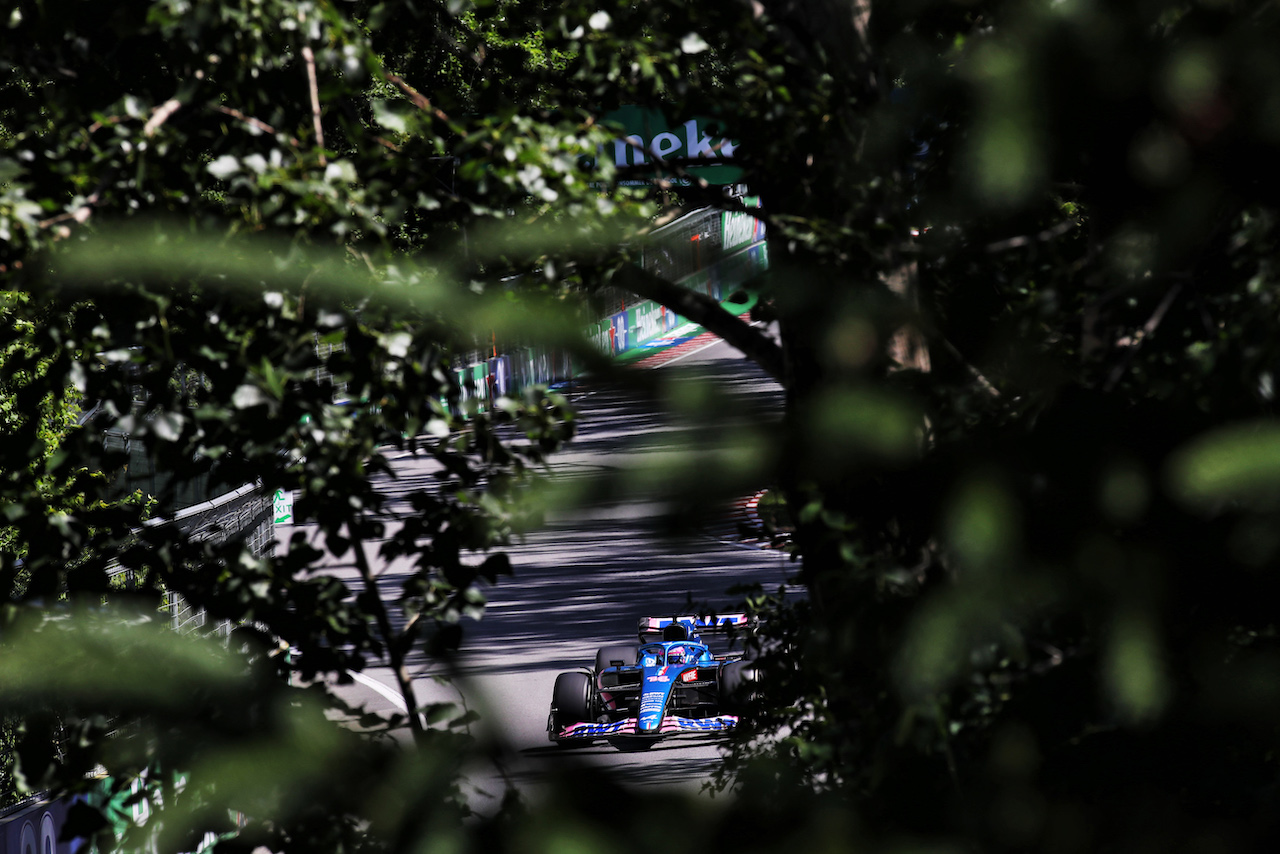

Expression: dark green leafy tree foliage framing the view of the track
xmin=0 ymin=0 xmax=1280 ymax=850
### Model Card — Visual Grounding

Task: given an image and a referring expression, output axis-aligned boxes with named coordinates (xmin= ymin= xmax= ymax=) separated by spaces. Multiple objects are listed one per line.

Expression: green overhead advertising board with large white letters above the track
xmin=602 ymin=106 xmax=742 ymax=184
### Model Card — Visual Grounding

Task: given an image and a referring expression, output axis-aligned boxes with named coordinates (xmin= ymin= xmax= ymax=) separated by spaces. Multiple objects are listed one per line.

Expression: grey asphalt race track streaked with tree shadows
xmin=279 ymin=332 xmax=792 ymax=812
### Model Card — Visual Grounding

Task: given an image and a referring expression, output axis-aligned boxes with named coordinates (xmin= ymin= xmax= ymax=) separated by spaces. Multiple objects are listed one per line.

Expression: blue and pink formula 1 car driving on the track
xmin=547 ymin=613 xmax=756 ymax=748
